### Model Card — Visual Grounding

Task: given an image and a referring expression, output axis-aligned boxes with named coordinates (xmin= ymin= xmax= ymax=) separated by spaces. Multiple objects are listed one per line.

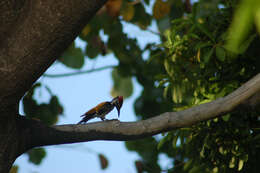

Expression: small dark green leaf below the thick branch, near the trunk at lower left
xmin=27 ymin=148 xmax=46 ymax=165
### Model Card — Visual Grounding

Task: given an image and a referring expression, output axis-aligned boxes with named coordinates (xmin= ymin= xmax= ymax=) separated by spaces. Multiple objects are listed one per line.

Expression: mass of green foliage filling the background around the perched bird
xmin=23 ymin=0 xmax=260 ymax=173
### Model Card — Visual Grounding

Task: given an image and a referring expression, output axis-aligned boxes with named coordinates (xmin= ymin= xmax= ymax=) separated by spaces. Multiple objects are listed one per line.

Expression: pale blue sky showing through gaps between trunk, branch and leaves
xmin=15 ymin=18 xmax=168 ymax=173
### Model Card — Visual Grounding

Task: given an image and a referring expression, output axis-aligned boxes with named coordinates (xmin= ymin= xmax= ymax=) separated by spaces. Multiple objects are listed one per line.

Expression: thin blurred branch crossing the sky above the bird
xmin=43 ymin=65 xmax=116 ymax=78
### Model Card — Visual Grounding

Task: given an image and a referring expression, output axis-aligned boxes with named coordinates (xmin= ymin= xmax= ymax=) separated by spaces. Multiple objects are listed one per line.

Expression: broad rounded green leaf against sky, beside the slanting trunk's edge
xmin=59 ymin=44 xmax=84 ymax=69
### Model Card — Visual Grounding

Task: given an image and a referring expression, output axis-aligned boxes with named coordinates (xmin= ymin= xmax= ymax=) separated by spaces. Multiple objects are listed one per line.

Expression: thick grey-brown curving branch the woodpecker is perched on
xmin=26 ymin=74 xmax=260 ymax=147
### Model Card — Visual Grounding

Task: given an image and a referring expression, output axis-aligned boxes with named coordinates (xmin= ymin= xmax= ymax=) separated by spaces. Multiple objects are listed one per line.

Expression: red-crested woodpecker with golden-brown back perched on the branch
xmin=78 ymin=96 xmax=123 ymax=124
